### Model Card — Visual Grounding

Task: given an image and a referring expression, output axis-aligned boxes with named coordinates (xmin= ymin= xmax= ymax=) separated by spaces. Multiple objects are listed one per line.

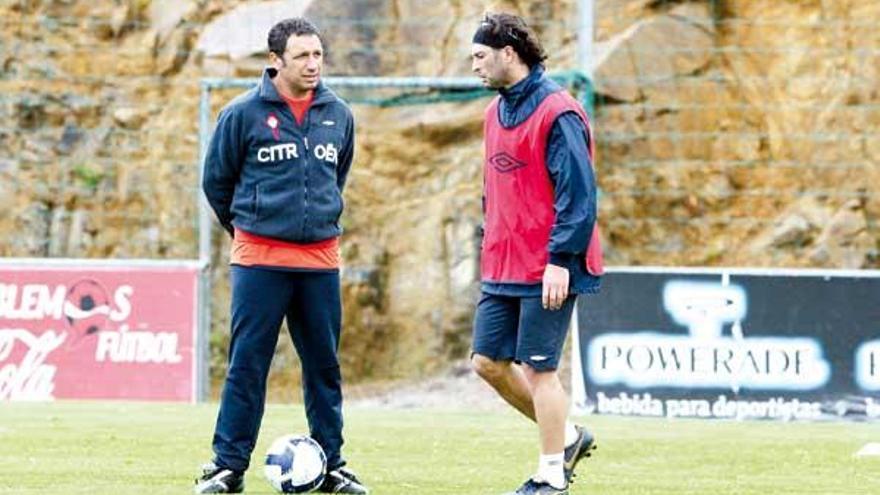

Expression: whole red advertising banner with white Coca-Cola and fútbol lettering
xmin=0 ymin=263 xmax=199 ymax=401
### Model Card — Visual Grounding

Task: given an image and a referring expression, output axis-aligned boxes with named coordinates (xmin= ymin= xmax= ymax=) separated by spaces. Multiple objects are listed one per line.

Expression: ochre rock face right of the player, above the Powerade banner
xmin=596 ymin=0 xmax=880 ymax=268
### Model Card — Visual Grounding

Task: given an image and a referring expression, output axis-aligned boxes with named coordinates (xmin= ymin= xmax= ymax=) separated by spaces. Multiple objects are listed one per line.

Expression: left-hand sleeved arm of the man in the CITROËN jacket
xmin=202 ymin=110 xmax=244 ymax=235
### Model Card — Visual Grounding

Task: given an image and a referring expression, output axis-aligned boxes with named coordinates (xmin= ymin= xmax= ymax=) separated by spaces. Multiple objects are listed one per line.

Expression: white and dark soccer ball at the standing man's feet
xmin=265 ymin=435 xmax=327 ymax=493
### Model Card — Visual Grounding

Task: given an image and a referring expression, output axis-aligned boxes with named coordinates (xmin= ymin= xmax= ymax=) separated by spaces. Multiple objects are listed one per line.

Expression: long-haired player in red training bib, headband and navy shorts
xmin=471 ymin=14 xmax=602 ymax=495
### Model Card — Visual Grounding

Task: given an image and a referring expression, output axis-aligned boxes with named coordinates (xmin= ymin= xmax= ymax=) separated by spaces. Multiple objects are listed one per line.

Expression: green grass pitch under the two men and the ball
xmin=0 ymin=402 xmax=880 ymax=495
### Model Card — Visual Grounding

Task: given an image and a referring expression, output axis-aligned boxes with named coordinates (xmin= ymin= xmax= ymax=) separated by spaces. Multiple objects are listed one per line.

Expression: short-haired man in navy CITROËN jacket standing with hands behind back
xmin=195 ymin=18 xmax=367 ymax=493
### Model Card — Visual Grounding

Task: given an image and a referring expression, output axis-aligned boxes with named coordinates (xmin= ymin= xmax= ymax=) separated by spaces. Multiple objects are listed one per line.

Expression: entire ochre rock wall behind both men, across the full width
xmin=0 ymin=0 xmax=880 ymax=392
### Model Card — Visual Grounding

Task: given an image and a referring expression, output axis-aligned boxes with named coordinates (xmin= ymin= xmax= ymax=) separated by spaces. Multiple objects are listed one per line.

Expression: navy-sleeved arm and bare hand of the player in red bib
xmin=543 ymin=112 xmax=596 ymax=309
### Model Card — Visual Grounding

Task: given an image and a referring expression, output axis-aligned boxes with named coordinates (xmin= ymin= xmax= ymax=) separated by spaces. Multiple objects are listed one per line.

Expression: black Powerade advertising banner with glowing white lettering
xmin=573 ymin=268 xmax=880 ymax=420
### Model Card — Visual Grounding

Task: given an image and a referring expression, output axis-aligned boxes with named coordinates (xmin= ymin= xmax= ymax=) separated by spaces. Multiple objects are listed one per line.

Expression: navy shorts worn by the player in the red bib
xmin=473 ymin=292 xmax=577 ymax=371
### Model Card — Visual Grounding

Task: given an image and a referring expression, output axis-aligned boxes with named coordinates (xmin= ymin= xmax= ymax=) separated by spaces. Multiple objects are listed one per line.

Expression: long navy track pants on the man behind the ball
xmin=213 ymin=265 xmax=345 ymax=471
